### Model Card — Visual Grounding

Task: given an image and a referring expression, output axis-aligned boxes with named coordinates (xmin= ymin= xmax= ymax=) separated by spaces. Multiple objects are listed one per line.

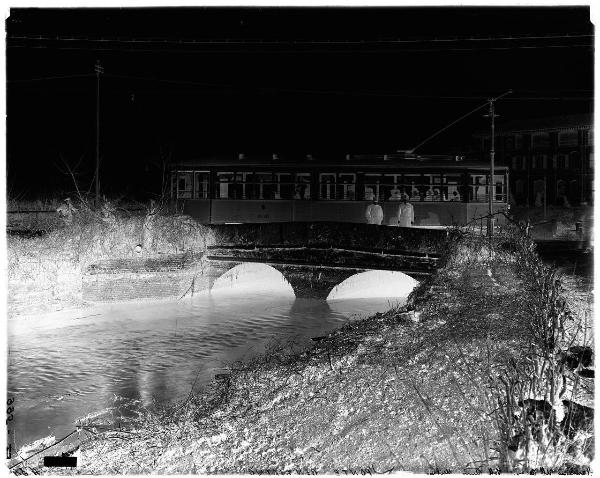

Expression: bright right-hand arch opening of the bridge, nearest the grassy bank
xmin=327 ymin=270 xmax=419 ymax=300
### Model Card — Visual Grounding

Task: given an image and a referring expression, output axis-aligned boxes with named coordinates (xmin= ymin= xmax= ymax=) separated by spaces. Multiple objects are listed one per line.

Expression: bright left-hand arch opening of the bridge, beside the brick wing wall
xmin=210 ymin=262 xmax=296 ymax=297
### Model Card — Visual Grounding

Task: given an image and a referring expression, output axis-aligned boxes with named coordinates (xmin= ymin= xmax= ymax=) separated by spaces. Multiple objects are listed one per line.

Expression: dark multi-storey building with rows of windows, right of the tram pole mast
xmin=476 ymin=114 xmax=594 ymax=207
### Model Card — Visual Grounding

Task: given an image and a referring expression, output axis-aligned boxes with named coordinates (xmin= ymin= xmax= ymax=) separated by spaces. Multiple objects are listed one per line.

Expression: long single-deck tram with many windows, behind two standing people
xmin=171 ymin=155 xmax=509 ymax=226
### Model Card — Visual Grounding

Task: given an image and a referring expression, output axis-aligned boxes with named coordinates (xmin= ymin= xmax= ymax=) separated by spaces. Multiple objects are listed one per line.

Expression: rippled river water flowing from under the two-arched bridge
xmin=8 ymin=288 xmax=403 ymax=449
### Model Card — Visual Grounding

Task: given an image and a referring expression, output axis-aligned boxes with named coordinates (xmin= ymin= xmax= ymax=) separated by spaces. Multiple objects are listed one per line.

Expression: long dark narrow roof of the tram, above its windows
xmin=174 ymin=153 xmax=508 ymax=170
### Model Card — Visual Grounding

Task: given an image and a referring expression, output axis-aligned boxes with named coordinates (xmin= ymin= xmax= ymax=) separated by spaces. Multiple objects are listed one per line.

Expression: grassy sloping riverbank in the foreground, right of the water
xmin=17 ymin=227 xmax=593 ymax=474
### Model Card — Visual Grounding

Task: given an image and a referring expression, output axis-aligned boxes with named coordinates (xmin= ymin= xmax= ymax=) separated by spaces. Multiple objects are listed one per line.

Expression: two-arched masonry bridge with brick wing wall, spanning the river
xmin=83 ymin=222 xmax=449 ymax=301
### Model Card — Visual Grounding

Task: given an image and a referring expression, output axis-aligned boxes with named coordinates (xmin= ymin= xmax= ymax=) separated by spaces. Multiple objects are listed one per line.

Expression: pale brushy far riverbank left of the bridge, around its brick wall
xmin=7 ymin=203 xmax=213 ymax=318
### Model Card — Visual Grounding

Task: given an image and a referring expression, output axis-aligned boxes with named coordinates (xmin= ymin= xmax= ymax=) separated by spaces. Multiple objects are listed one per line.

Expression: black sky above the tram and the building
xmin=6 ymin=7 xmax=594 ymax=196
